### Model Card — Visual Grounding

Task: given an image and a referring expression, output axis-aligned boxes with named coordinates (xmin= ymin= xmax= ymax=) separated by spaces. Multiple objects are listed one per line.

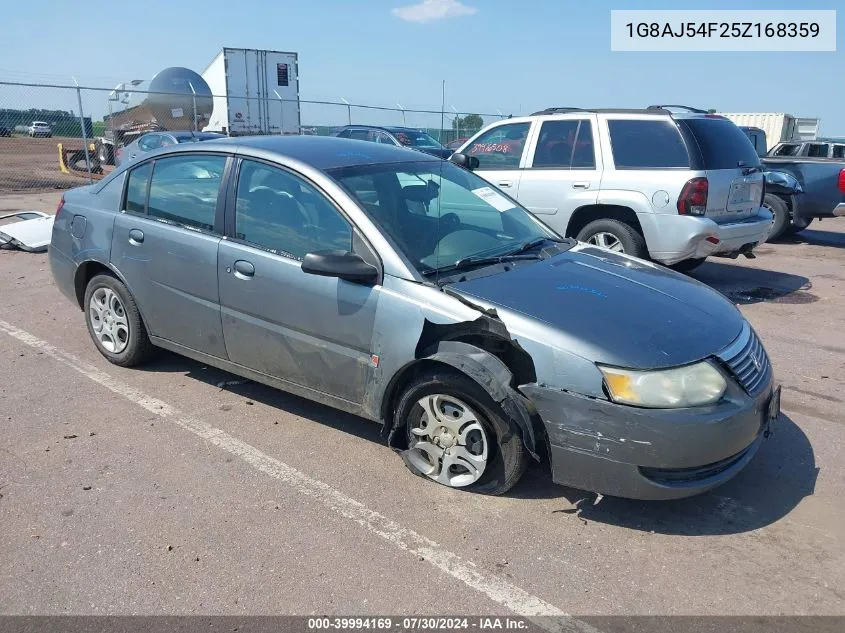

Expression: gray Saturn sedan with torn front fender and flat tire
xmin=50 ymin=136 xmax=780 ymax=499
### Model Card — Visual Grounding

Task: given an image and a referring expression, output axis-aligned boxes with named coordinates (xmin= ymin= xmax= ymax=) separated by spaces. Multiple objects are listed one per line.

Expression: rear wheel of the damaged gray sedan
xmin=83 ymin=274 xmax=154 ymax=367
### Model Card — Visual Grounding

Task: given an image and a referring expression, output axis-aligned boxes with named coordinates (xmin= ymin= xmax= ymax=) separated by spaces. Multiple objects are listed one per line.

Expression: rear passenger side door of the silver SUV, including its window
xmin=519 ymin=114 xmax=601 ymax=231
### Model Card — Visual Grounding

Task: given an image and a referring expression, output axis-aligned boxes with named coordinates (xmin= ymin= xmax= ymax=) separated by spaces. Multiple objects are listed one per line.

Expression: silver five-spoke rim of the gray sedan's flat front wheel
xmin=408 ymin=394 xmax=488 ymax=488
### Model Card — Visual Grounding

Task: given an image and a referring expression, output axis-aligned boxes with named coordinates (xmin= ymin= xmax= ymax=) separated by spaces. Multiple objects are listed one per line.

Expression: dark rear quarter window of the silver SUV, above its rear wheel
xmin=607 ymin=119 xmax=684 ymax=169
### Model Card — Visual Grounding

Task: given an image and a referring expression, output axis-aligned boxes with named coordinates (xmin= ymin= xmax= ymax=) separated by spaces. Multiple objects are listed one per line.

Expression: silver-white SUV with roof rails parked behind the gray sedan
xmin=457 ymin=106 xmax=772 ymax=270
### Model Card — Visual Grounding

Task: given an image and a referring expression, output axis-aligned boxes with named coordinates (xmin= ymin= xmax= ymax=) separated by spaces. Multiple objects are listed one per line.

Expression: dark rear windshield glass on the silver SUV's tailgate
xmin=678 ymin=117 xmax=760 ymax=170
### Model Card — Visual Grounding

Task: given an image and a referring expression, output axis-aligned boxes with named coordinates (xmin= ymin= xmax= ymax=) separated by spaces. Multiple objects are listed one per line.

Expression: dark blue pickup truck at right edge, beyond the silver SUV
xmin=740 ymin=127 xmax=845 ymax=240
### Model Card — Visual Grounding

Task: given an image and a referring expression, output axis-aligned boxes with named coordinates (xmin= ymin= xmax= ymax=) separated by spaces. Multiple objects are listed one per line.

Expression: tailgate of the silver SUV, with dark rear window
xmin=678 ymin=116 xmax=764 ymax=224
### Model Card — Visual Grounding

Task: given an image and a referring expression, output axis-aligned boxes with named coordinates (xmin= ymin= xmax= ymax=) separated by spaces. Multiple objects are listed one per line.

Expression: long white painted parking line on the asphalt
xmin=0 ymin=320 xmax=596 ymax=633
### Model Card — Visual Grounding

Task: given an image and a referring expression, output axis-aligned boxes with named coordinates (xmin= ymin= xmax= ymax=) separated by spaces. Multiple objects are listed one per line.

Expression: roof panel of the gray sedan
xmin=158 ymin=136 xmax=441 ymax=171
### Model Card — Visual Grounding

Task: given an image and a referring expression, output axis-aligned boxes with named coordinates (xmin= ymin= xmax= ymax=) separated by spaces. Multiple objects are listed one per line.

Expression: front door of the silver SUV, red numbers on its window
xmin=462 ymin=121 xmax=531 ymax=198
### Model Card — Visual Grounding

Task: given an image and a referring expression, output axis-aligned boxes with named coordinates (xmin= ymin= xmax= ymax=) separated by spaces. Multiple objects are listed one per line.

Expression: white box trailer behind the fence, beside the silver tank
xmin=202 ymin=48 xmax=300 ymax=136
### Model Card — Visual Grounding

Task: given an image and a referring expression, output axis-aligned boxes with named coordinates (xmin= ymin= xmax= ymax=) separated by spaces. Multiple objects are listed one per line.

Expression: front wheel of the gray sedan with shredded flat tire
xmin=396 ymin=369 xmax=528 ymax=495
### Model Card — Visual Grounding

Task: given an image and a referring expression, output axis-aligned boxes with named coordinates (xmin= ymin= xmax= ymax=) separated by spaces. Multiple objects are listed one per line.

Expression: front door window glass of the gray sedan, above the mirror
xmin=235 ymin=160 xmax=352 ymax=259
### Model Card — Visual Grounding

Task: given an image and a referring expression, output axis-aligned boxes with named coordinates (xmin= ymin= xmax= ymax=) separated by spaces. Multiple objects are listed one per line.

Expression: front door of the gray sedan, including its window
xmin=218 ymin=160 xmax=379 ymax=404
